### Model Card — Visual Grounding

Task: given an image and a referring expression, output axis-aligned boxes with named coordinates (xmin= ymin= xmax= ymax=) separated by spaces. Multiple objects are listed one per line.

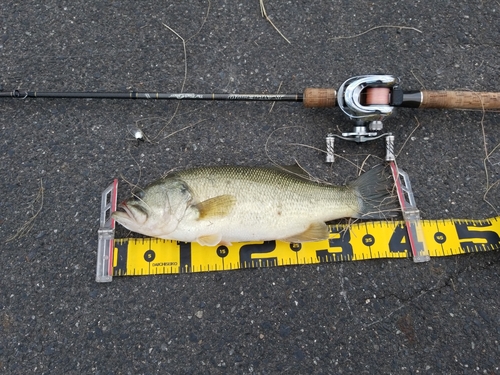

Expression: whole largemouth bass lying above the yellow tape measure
xmin=112 ymin=166 xmax=396 ymax=246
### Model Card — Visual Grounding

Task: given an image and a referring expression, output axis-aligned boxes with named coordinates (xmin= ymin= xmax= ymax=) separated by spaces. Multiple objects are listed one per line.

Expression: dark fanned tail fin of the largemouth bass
xmin=349 ymin=165 xmax=401 ymax=219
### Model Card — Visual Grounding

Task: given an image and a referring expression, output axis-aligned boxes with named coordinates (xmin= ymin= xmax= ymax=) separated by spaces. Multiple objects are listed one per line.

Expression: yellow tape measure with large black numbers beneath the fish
xmin=110 ymin=216 xmax=500 ymax=276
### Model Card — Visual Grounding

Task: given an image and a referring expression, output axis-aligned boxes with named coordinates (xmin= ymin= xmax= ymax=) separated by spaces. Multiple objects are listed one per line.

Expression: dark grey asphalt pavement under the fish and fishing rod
xmin=0 ymin=0 xmax=500 ymax=375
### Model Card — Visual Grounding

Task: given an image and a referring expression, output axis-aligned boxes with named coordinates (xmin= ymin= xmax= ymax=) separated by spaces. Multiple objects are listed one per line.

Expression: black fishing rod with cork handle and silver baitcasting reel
xmin=0 ymin=75 xmax=500 ymax=143
